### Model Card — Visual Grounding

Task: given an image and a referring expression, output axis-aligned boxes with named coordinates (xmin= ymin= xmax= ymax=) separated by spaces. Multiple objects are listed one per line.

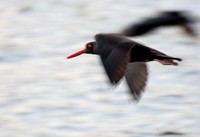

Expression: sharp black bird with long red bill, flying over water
xmin=67 ymin=34 xmax=181 ymax=101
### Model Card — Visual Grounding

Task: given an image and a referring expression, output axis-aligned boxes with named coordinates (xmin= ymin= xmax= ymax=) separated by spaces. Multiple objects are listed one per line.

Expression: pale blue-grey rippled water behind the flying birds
xmin=0 ymin=0 xmax=200 ymax=137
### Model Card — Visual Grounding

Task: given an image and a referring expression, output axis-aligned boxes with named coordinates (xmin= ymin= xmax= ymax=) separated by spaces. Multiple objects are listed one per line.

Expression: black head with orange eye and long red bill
xmin=67 ymin=42 xmax=97 ymax=59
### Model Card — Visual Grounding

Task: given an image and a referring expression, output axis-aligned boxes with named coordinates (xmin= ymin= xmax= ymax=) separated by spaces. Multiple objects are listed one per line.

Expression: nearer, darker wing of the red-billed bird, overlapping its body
xmin=95 ymin=34 xmax=134 ymax=84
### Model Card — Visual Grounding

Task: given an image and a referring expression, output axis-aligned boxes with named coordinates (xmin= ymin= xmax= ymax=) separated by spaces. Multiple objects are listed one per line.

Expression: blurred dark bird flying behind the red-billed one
xmin=122 ymin=11 xmax=197 ymax=37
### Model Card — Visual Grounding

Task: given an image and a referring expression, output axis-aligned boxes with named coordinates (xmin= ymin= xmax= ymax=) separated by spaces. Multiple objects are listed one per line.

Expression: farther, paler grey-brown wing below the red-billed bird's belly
xmin=125 ymin=62 xmax=148 ymax=101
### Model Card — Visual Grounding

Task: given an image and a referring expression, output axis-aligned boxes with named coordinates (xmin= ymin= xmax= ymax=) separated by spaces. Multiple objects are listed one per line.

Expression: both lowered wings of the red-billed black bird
xmin=95 ymin=34 xmax=148 ymax=101
